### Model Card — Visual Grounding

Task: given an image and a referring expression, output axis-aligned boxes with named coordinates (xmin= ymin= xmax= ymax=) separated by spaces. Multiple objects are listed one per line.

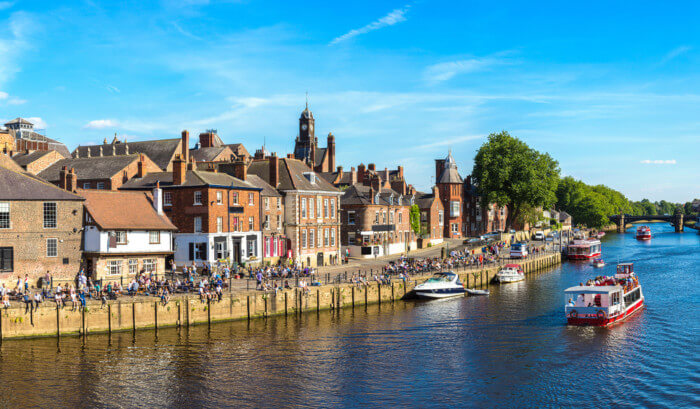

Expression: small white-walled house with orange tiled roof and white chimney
xmin=77 ymin=186 xmax=177 ymax=284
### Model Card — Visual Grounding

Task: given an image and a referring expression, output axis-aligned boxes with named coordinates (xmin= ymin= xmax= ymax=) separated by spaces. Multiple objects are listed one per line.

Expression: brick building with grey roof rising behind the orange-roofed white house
xmin=38 ymin=154 xmax=161 ymax=190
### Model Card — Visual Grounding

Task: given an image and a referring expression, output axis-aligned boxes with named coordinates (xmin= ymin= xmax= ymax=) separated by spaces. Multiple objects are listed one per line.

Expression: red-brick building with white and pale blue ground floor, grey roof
xmin=121 ymin=154 xmax=262 ymax=268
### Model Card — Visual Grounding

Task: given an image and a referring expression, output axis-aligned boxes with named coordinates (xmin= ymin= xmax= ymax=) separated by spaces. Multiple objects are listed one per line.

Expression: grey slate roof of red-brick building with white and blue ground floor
xmin=120 ymin=170 xmax=260 ymax=190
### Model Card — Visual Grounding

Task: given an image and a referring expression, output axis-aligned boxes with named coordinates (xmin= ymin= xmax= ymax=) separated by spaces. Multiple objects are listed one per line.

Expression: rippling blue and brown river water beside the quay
xmin=0 ymin=223 xmax=700 ymax=408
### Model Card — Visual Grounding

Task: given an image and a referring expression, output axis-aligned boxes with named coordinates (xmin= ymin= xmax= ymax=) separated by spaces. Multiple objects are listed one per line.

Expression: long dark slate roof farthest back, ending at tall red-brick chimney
xmin=73 ymin=138 xmax=182 ymax=170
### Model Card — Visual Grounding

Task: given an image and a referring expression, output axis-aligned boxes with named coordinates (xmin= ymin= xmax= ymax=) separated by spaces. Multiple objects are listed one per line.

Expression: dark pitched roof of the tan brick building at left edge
xmin=0 ymin=163 xmax=83 ymax=200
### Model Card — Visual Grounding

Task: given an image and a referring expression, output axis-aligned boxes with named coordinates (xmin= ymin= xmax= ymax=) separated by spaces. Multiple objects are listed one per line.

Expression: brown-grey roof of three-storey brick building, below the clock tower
xmin=248 ymin=158 xmax=339 ymax=192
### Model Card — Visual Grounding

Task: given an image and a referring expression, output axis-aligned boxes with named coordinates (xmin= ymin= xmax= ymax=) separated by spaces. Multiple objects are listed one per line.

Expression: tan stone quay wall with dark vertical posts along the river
xmin=0 ymin=253 xmax=562 ymax=342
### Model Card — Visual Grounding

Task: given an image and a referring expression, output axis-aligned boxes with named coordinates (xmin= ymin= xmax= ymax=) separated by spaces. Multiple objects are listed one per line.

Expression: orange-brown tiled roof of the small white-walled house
xmin=78 ymin=190 xmax=177 ymax=230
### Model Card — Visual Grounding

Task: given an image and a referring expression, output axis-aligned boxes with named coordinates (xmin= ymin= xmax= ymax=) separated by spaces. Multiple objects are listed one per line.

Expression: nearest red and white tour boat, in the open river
xmin=564 ymin=263 xmax=644 ymax=327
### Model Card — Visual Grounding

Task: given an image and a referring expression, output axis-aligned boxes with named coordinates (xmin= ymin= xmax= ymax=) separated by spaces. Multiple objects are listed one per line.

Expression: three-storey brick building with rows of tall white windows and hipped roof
xmin=248 ymin=154 xmax=342 ymax=266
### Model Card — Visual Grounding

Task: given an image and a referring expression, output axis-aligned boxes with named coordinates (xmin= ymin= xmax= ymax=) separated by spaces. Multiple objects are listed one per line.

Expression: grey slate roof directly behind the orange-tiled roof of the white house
xmin=38 ymin=154 xmax=139 ymax=182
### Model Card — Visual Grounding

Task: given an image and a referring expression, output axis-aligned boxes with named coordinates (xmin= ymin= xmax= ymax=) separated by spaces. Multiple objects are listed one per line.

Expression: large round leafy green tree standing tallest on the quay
xmin=472 ymin=131 xmax=559 ymax=229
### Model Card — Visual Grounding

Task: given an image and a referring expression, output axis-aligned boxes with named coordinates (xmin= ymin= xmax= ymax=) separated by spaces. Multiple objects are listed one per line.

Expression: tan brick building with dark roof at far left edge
xmin=0 ymin=159 xmax=84 ymax=287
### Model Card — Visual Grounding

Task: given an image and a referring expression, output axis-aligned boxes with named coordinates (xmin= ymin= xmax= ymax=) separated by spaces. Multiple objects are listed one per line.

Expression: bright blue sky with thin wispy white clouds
xmin=0 ymin=0 xmax=700 ymax=202
